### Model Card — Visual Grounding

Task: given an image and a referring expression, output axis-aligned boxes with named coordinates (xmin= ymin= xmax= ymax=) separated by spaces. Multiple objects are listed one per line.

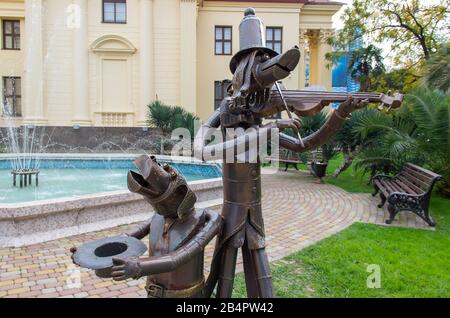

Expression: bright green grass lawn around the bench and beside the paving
xmin=234 ymin=158 xmax=450 ymax=297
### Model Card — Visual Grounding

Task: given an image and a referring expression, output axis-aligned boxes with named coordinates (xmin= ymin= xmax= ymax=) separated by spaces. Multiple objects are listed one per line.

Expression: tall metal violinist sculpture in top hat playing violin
xmin=194 ymin=8 xmax=403 ymax=298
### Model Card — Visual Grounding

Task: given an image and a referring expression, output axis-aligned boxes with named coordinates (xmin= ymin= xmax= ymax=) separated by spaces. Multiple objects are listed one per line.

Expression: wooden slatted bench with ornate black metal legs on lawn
xmin=371 ymin=163 xmax=442 ymax=226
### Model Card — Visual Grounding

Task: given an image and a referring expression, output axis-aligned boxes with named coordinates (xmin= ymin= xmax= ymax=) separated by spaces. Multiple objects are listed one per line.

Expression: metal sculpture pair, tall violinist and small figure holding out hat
xmin=71 ymin=8 xmax=403 ymax=298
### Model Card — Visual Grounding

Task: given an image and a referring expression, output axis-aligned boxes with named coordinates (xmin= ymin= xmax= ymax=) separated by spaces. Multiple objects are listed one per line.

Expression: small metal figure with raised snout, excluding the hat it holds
xmin=72 ymin=156 xmax=222 ymax=298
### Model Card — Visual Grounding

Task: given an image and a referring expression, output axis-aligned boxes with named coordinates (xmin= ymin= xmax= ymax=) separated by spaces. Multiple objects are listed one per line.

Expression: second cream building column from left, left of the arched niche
xmin=72 ymin=0 xmax=91 ymax=126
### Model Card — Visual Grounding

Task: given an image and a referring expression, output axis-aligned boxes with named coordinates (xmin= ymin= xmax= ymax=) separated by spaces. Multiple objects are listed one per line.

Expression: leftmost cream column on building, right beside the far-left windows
xmin=23 ymin=0 xmax=47 ymax=125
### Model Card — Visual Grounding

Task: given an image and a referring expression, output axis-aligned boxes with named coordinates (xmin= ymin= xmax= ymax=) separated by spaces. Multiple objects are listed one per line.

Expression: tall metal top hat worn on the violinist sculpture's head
xmin=230 ymin=8 xmax=278 ymax=73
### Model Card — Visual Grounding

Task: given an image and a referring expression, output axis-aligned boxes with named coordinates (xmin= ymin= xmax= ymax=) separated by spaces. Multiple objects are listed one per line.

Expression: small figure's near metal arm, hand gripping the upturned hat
xmin=111 ymin=210 xmax=222 ymax=281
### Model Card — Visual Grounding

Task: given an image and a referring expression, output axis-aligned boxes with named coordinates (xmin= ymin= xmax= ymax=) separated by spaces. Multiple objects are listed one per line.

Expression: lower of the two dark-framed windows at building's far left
xmin=3 ymin=77 xmax=22 ymax=117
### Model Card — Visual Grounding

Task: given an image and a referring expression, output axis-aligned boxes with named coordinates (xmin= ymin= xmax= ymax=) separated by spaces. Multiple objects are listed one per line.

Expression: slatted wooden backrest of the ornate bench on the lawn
xmin=397 ymin=163 xmax=441 ymax=194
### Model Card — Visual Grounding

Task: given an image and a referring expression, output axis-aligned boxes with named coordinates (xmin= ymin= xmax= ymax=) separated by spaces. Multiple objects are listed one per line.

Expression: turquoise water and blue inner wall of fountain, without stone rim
xmin=0 ymin=154 xmax=221 ymax=204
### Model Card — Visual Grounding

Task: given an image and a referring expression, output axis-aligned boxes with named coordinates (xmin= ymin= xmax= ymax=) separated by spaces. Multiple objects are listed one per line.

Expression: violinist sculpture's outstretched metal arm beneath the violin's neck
xmin=280 ymin=99 xmax=367 ymax=152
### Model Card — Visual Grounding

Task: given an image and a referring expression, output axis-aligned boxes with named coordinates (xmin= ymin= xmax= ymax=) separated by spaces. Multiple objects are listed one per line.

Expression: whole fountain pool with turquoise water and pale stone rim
xmin=0 ymin=154 xmax=223 ymax=247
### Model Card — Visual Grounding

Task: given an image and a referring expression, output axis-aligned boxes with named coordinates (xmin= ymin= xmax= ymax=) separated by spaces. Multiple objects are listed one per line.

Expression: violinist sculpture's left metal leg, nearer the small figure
xmin=216 ymin=246 xmax=238 ymax=298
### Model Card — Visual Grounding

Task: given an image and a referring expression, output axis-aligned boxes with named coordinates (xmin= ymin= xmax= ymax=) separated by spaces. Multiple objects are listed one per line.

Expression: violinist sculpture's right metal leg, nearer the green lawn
xmin=251 ymin=248 xmax=275 ymax=298
